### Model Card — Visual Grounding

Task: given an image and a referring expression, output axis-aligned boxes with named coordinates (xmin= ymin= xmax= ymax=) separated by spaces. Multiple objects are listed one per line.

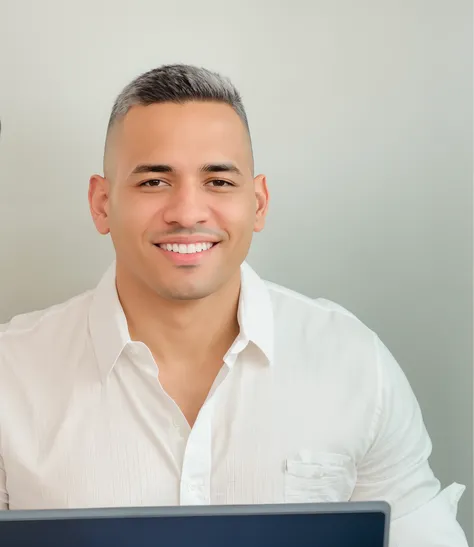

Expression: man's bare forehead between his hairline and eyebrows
xmin=110 ymin=103 xmax=252 ymax=178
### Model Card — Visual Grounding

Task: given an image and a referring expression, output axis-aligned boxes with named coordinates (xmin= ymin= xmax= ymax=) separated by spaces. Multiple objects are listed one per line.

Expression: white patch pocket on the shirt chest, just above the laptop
xmin=285 ymin=452 xmax=357 ymax=503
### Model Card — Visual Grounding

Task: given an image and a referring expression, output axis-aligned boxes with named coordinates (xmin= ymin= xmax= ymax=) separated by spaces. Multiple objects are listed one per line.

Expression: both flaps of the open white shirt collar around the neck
xmin=89 ymin=262 xmax=274 ymax=379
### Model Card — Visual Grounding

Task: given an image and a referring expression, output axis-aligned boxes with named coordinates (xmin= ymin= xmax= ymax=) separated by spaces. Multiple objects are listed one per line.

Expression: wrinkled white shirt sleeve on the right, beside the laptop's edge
xmin=352 ymin=336 xmax=468 ymax=547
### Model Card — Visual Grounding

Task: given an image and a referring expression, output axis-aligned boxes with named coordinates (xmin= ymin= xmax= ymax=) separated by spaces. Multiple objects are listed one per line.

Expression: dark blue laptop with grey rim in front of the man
xmin=0 ymin=502 xmax=390 ymax=547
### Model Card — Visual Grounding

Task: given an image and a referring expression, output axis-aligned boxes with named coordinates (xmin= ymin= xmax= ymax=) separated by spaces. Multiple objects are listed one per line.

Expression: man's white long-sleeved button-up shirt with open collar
xmin=0 ymin=263 xmax=467 ymax=547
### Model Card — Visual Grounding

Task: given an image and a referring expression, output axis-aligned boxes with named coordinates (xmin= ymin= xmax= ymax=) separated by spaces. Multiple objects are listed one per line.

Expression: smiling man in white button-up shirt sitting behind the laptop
xmin=0 ymin=65 xmax=466 ymax=547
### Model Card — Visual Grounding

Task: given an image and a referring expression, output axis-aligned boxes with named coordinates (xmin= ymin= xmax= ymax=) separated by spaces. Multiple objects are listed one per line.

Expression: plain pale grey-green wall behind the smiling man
xmin=0 ymin=0 xmax=473 ymax=541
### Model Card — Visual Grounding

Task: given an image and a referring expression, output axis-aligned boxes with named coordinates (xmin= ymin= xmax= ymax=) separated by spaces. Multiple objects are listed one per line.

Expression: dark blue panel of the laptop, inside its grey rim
xmin=0 ymin=512 xmax=386 ymax=547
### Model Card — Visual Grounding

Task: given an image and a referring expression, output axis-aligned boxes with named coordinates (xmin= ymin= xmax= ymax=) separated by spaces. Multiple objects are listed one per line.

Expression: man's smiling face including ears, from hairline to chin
xmin=89 ymin=102 xmax=268 ymax=300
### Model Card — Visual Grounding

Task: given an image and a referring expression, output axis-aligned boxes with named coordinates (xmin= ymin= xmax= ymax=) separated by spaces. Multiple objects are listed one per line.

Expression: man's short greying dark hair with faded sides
xmin=104 ymin=64 xmax=251 ymax=176
